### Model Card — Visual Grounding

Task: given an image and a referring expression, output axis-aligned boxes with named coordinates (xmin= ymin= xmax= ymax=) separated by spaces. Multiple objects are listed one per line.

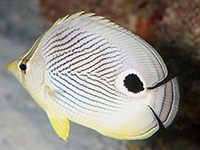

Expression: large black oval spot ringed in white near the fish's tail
xmin=124 ymin=73 xmax=144 ymax=93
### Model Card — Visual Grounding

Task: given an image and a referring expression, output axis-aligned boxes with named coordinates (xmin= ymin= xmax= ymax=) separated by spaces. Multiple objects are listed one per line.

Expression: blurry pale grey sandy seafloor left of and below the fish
xmin=0 ymin=0 xmax=127 ymax=150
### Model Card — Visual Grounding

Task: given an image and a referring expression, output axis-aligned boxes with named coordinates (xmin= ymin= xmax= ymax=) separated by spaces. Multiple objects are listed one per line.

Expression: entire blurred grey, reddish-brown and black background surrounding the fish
xmin=0 ymin=0 xmax=200 ymax=150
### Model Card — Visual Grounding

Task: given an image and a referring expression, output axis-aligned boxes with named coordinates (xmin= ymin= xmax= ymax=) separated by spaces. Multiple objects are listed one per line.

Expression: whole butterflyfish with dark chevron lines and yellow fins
xmin=7 ymin=12 xmax=179 ymax=141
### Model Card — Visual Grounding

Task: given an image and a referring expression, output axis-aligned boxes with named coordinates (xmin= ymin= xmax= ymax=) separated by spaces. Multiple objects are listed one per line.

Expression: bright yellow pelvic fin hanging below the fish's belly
xmin=47 ymin=113 xmax=70 ymax=141
